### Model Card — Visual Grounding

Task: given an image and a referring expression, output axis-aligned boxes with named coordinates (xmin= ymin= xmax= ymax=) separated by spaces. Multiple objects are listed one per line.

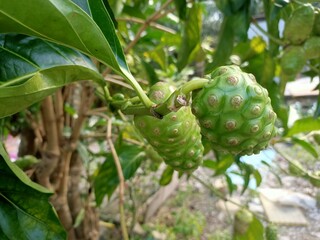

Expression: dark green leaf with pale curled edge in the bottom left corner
xmin=0 ymin=144 xmax=66 ymax=240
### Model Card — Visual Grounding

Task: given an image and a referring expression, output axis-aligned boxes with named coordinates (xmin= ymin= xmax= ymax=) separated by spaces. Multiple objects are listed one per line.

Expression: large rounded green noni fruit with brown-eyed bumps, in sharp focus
xmin=192 ymin=66 xmax=276 ymax=155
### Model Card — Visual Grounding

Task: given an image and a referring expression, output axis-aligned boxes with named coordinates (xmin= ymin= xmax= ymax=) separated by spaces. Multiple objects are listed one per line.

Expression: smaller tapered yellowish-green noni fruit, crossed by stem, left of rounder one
xmin=134 ymin=83 xmax=203 ymax=172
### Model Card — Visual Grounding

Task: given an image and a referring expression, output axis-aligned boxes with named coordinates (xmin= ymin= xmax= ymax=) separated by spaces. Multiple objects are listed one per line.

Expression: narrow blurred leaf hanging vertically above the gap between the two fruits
xmin=177 ymin=4 xmax=202 ymax=71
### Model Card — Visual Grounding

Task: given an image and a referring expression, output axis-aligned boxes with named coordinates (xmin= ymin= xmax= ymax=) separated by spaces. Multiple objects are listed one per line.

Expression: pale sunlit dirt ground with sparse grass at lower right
xmin=149 ymin=145 xmax=320 ymax=240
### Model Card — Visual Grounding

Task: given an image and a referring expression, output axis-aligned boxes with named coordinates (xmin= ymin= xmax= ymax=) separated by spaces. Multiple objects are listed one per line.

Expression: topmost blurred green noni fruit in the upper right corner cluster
xmin=283 ymin=4 xmax=315 ymax=44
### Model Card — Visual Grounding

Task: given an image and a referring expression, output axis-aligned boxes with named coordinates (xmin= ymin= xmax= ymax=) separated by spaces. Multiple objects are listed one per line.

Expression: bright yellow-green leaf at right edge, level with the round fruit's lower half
xmin=286 ymin=117 xmax=320 ymax=137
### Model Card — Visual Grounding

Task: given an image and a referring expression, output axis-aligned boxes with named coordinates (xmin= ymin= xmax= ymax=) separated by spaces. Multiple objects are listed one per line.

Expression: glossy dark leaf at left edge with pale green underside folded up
xmin=0 ymin=34 xmax=103 ymax=118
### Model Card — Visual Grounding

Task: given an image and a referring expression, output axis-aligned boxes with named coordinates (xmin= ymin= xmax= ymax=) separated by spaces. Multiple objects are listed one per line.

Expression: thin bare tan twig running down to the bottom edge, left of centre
xmin=106 ymin=119 xmax=129 ymax=240
